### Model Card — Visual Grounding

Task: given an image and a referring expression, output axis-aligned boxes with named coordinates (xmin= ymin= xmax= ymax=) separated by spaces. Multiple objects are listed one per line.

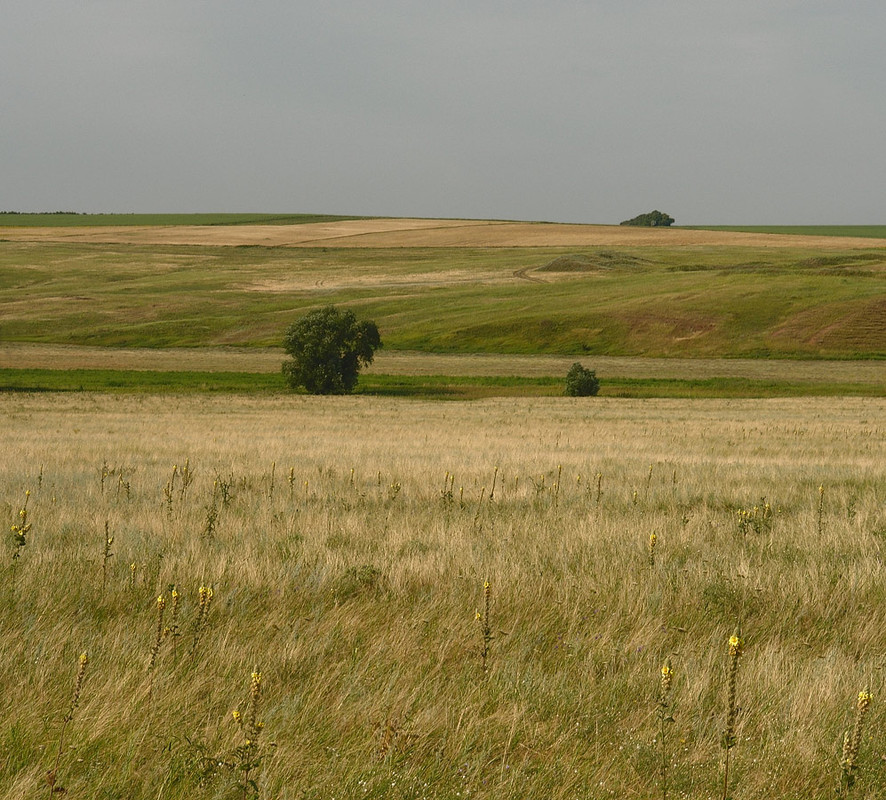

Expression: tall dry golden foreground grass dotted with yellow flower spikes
xmin=0 ymin=395 xmax=886 ymax=800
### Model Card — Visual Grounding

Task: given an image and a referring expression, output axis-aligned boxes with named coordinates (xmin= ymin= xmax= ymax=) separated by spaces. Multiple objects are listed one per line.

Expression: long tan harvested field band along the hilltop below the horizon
xmin=0 ymin=219 xmax=886 ymax=250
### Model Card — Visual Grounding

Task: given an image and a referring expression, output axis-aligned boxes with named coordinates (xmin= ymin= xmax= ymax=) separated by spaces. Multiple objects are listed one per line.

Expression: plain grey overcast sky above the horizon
xmin=0 ymin=0 xmax=886 ymax=225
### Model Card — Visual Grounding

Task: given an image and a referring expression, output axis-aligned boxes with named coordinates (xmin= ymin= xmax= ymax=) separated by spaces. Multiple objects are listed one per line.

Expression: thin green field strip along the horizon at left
xmin=0 ymin=212 xmax=365 ymax=228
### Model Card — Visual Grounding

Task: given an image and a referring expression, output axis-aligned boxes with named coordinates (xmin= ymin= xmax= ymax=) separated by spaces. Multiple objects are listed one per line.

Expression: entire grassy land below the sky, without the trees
xmin=0 ymin=215 xmax=886 ymax=800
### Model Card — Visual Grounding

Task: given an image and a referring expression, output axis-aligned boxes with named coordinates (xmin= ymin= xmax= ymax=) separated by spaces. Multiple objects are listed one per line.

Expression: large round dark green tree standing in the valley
xmin=283 ymin=306 xmax=382 ymax=394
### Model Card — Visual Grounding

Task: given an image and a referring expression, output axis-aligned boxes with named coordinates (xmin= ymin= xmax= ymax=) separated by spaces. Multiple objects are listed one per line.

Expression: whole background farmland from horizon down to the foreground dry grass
xmin=0 ymin=214 xmax=886 ymax=399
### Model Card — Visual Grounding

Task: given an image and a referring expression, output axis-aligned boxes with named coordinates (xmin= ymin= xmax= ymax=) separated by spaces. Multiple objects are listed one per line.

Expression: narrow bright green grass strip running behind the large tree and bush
xmin=0 ymin=369 xmax=886 ymax=400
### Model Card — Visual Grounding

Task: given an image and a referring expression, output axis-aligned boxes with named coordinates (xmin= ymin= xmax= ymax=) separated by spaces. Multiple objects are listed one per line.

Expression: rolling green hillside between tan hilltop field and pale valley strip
xmin=0 ymin=240 xmax=886 ymax=359
